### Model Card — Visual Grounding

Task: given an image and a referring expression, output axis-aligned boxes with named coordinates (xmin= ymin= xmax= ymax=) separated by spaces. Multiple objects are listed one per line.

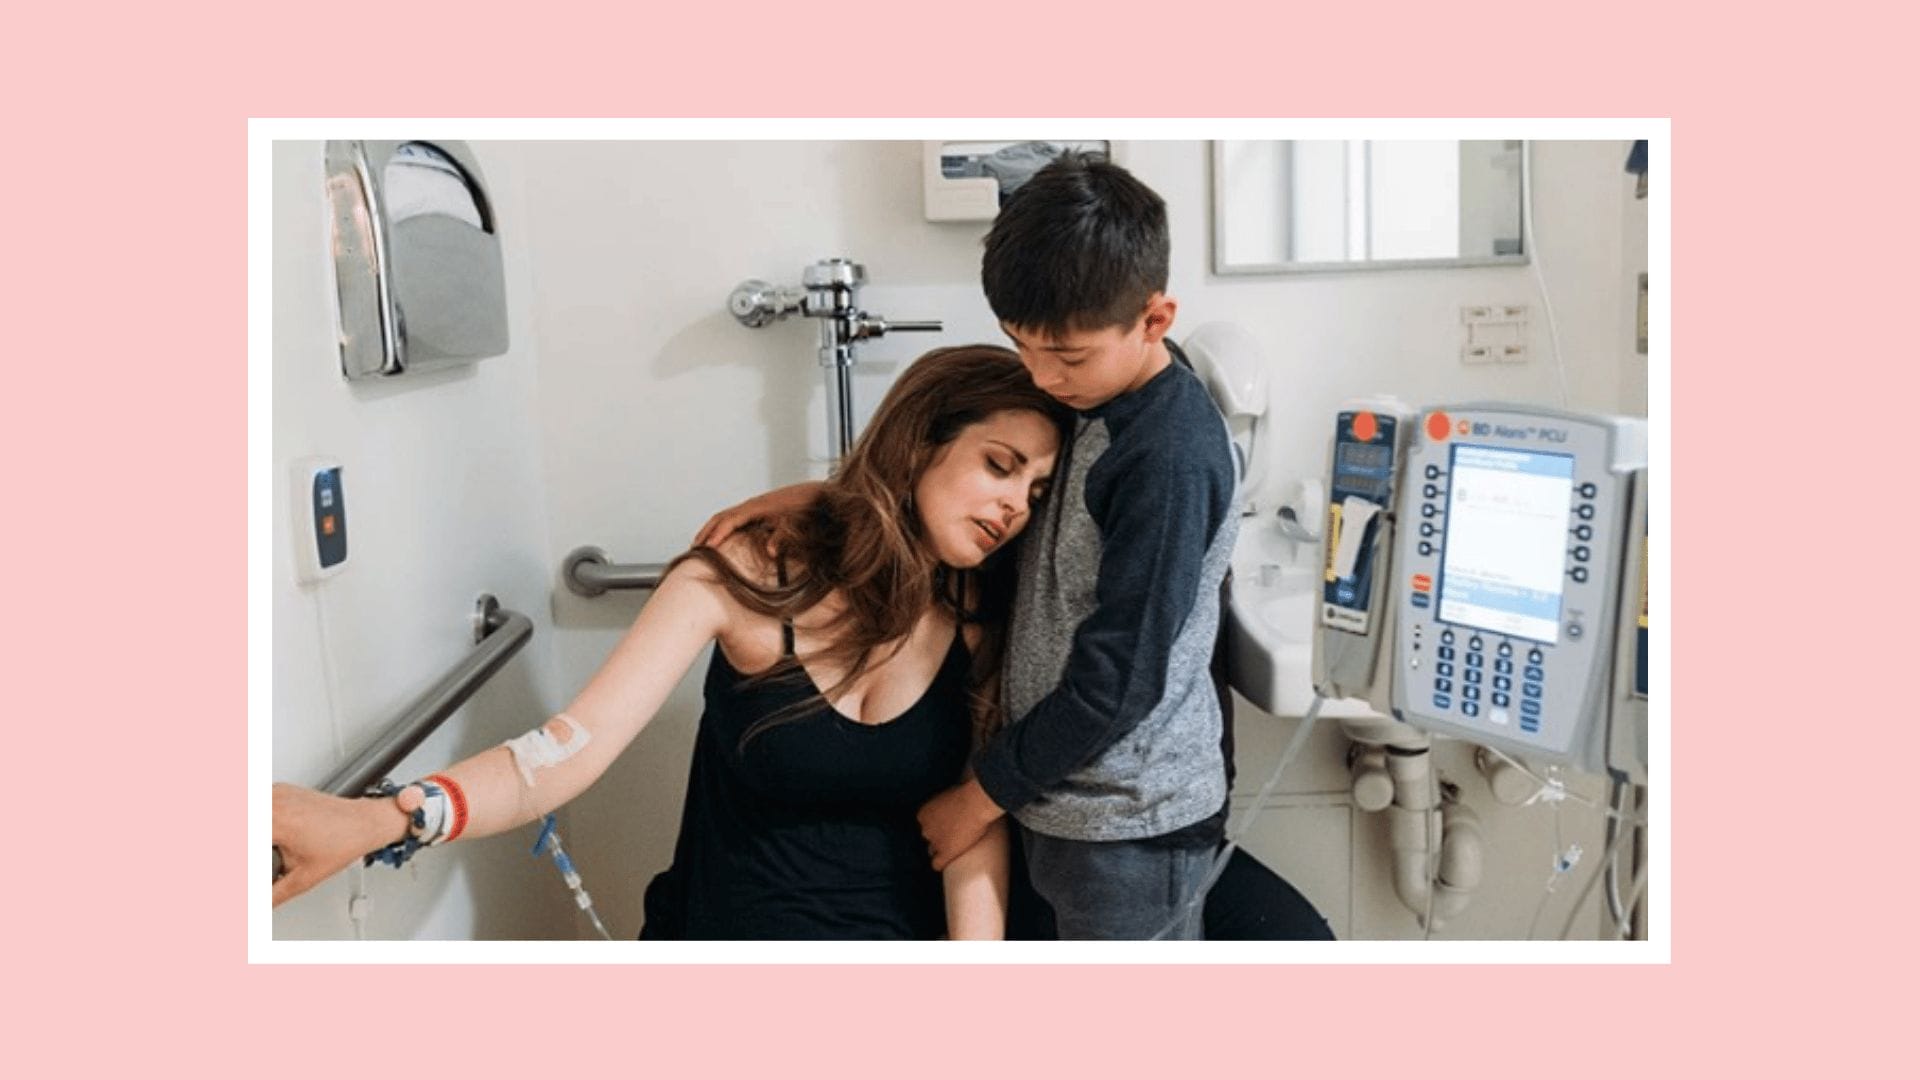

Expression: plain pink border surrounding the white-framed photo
xmin=11 ymin=2 xmax=1858 ymax=1076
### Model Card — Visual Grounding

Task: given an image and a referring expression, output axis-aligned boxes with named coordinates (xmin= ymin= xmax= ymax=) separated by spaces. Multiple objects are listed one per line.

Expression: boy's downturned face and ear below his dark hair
xmin=1000 ymin=292 xmax=1175 ymax=409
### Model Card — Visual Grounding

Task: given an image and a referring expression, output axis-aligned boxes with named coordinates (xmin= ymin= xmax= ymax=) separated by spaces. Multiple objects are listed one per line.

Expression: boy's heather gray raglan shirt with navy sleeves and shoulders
xmin=973 ymin=342 xmax=1240 ymax=840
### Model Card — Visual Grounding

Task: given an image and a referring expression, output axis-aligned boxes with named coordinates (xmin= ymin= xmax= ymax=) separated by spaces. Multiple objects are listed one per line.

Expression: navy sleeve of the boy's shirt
xmin=973 ymin=428 xmax=1233 ymax=809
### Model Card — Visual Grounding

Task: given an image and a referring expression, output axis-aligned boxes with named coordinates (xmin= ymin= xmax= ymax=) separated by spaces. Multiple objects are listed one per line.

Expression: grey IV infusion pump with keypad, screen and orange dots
xmin=1313 ymin=404 xmax=1647 ymax=782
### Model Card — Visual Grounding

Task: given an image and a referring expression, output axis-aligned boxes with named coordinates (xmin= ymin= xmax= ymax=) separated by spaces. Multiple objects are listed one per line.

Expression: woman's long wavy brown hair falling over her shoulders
xmin=668 ymin=346 xmax=1073 ymax=744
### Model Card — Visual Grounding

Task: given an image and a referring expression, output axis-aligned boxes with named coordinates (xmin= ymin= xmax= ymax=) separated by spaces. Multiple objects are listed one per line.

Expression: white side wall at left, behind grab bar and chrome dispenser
xmin=273 ymin=142 xmax=572 ymax=938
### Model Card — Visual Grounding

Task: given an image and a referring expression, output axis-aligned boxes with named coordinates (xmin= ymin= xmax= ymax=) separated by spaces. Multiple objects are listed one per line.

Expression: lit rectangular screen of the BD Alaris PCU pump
xmin=1440 ymin=444 xmax=1572 ymax=644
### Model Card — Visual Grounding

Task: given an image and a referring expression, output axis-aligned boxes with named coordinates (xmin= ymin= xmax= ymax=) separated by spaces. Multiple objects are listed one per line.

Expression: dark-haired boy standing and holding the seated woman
xmin=920 ymin=156 xmax=1238 ymax=940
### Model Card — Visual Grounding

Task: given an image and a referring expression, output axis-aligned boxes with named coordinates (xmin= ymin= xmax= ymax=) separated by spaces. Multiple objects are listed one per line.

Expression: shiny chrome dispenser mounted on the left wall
xmin=326 ymin=140 xmax=507 ymax=379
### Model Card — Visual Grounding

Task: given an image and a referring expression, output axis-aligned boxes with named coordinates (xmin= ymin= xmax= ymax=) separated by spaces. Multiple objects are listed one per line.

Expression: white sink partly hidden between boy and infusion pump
xmin=1223 ymin=517 xmax=1371 ymax=717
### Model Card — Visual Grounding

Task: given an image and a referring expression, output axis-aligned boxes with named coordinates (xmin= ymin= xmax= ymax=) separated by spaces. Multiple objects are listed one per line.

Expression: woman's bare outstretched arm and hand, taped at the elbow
xmin=273 ymin=561 xmax=730 ymax=907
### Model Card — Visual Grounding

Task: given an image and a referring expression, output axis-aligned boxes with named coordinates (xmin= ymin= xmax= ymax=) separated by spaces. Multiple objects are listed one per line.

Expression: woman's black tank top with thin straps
xmin=639 ymin=599 xmax=972 ymax=940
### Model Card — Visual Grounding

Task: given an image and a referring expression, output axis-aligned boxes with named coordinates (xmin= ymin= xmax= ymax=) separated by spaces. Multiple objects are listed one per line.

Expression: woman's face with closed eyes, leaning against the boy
xmin=914 ymin=409 xmax=1060 ymax=569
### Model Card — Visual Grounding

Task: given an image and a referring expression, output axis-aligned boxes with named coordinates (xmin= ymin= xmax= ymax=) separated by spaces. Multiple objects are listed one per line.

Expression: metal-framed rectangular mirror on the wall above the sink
xmin=1213 ymin=138 xmax=1528 ymax=275
